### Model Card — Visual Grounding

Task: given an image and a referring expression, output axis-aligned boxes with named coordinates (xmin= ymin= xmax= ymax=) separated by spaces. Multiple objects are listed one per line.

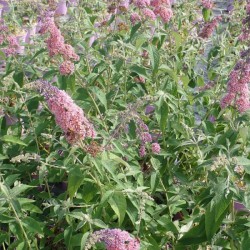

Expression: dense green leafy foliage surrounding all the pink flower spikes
xmin=0 ymin=0 xmax=250 ymax=250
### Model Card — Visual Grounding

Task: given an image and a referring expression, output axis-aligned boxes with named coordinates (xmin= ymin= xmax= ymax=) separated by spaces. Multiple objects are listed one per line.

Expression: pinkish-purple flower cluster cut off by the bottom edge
xmin=85 ymin=229 xmax=140 ymax=250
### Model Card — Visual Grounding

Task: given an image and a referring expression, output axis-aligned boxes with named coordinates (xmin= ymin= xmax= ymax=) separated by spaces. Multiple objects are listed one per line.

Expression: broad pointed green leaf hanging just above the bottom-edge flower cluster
xmin=109 ymin=192 xmax=127 ymax=226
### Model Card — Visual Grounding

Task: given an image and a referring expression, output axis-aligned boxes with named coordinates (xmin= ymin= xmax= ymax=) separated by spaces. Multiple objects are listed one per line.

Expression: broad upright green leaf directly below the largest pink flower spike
xmin=68 ymin=166 xmax=83 ymax=199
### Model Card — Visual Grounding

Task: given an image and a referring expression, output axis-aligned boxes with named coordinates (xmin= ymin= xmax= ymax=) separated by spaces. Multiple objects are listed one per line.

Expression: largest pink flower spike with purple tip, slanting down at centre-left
xmin=36 ymin=81 xmax=96 ymax=144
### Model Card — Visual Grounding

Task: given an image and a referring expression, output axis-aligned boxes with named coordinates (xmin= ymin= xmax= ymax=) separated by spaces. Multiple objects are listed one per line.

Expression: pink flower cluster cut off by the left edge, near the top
xmin=0 ymin=19 xmax=21 ymax=56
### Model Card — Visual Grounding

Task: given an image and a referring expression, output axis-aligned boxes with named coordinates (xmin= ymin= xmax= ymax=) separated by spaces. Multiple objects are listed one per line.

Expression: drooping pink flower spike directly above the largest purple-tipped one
xmin=40 ymin=12 xmax=79 ymax=75
